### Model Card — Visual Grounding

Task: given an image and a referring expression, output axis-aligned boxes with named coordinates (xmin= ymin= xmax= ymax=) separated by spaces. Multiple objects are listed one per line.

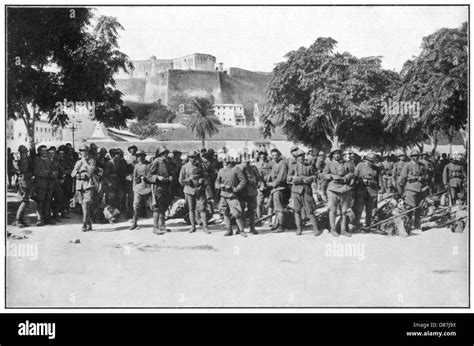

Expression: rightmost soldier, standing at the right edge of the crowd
xmin=443 ymin=152 xmax=466 ymax=205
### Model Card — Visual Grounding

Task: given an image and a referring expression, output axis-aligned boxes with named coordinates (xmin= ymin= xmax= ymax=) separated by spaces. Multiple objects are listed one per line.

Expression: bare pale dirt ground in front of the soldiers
xmin=7 ymin=208 xmax=468 ymax=307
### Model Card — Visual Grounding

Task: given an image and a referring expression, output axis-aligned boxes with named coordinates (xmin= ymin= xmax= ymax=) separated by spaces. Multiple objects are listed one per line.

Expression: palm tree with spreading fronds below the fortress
xmin=187 ymin=97 xmax=221 ymax=148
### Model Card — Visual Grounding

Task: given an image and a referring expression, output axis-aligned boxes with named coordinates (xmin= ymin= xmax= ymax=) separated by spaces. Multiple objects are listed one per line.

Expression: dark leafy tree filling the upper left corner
xmin=7 ymin=7 xmax=133 ymax=149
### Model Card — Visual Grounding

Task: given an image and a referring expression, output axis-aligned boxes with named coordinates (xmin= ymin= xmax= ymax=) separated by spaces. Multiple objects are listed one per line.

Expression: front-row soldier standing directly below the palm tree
xmin=179 ymin=150 xmax=211 ymax=234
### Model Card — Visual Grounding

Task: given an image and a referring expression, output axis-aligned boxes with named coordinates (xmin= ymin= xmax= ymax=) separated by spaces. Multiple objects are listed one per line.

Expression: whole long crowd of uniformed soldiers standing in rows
xmin=13 ymin=143 xmax=467 ymax=237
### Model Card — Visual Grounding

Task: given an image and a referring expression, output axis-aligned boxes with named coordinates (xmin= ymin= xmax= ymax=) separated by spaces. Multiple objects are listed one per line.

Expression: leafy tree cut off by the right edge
xmin=384 ymin=23 xmax=468 ymax=153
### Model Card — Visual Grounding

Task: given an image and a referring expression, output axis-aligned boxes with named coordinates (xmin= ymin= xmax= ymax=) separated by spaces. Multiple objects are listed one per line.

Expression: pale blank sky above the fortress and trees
xmin=96 ymin=6 xmax=467 ymax=72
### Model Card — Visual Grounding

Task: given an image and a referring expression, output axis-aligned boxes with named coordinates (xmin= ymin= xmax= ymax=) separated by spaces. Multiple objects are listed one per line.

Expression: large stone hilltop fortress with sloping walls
xmin=115 ymin=53 xmax=270 ymax=123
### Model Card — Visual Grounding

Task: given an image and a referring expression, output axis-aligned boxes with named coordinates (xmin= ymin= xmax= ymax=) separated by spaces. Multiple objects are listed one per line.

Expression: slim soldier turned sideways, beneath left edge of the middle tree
xmin=268 ymin=148 xmax=288 ymax=233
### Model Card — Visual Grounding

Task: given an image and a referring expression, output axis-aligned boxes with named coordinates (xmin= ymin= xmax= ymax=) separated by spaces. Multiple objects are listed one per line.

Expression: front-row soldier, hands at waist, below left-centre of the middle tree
xmin=287 ymin=150 xmax=323 ymax=236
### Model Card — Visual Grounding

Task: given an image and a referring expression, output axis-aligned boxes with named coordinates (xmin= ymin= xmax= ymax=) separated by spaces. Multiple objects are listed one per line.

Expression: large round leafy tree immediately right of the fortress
xmin=262 ymin=38 xmax=398 ymax=148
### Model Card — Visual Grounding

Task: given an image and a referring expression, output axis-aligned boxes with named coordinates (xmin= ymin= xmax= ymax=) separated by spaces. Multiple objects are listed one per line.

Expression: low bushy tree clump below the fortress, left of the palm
xmin=127 ymin=100 xmax=176 ymax=139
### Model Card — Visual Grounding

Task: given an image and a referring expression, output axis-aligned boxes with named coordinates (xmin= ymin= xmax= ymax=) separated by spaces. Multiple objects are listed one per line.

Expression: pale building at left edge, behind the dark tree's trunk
xmin=7 ymin=118 xmax=63 ymax=151
